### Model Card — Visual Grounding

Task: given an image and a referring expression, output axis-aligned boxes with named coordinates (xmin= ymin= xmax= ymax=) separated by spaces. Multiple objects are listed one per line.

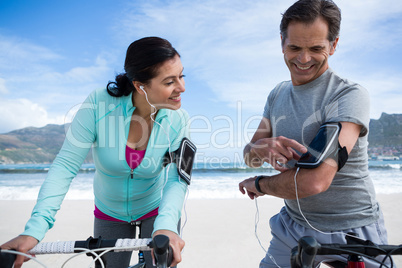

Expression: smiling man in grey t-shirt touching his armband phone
xmin=239 ymin=0 xmax=387 ymax=267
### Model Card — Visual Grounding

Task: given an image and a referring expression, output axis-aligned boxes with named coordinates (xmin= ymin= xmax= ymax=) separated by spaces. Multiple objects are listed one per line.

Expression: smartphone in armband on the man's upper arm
xmin=295 ymin=122 xmax=342 ymax=168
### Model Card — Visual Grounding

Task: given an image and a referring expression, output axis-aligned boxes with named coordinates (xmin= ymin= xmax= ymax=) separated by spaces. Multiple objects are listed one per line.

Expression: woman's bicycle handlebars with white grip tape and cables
xmin=0 ymin=235 xmax=173 ymax=268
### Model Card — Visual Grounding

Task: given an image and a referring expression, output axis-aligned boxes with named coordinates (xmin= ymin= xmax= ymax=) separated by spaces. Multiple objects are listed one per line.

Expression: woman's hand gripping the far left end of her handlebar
xmin=1 ymin=235 xmax=38 ymax=268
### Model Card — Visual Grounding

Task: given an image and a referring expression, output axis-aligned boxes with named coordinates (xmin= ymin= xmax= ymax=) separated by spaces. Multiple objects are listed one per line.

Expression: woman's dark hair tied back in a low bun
xmin=106 ymin=37 xmax=180 ymax=97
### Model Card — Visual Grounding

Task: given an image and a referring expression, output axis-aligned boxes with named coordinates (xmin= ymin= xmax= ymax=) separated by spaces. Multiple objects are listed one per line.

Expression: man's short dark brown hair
xmin=280 ymin=0 xmax=341 ymax=45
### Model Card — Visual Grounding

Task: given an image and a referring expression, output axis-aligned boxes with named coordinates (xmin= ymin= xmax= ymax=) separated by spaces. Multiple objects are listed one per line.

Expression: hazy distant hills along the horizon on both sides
xmin=0 ymin=113 xmax=402 ymax=164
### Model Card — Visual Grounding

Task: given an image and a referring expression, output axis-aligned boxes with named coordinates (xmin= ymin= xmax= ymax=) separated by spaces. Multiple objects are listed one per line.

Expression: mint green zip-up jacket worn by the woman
xmin=22 ymin=89 xmax=188 ymax=241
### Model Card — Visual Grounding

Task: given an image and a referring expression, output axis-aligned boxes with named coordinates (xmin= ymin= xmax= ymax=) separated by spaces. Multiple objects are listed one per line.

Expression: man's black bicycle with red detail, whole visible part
xmin=290 ymin=234 xmax=402 ymax=268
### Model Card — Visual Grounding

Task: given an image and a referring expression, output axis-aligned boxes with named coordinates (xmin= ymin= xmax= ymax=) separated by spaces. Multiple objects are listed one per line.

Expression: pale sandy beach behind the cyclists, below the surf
xmin=0 ymin=194 xmax=402 ymax=268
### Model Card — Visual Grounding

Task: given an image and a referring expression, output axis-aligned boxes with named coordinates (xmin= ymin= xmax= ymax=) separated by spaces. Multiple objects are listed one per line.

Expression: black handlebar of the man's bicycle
xmin=291 ymin=236 xmax=402 ymax=268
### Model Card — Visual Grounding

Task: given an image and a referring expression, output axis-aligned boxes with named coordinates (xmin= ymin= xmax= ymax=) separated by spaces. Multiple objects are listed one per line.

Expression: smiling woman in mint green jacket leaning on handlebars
xmin=1 ymin=37 xmax=188 ymax=268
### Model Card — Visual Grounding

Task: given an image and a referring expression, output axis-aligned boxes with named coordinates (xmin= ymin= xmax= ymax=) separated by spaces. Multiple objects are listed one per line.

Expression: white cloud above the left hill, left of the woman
xmin=0 ymin=36 xmax=113 ymax=131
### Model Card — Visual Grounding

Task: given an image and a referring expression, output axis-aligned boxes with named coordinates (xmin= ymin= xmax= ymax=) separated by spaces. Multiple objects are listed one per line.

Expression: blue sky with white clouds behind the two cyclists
xmin=0 ymin=0 xmax=402 ymax=161
